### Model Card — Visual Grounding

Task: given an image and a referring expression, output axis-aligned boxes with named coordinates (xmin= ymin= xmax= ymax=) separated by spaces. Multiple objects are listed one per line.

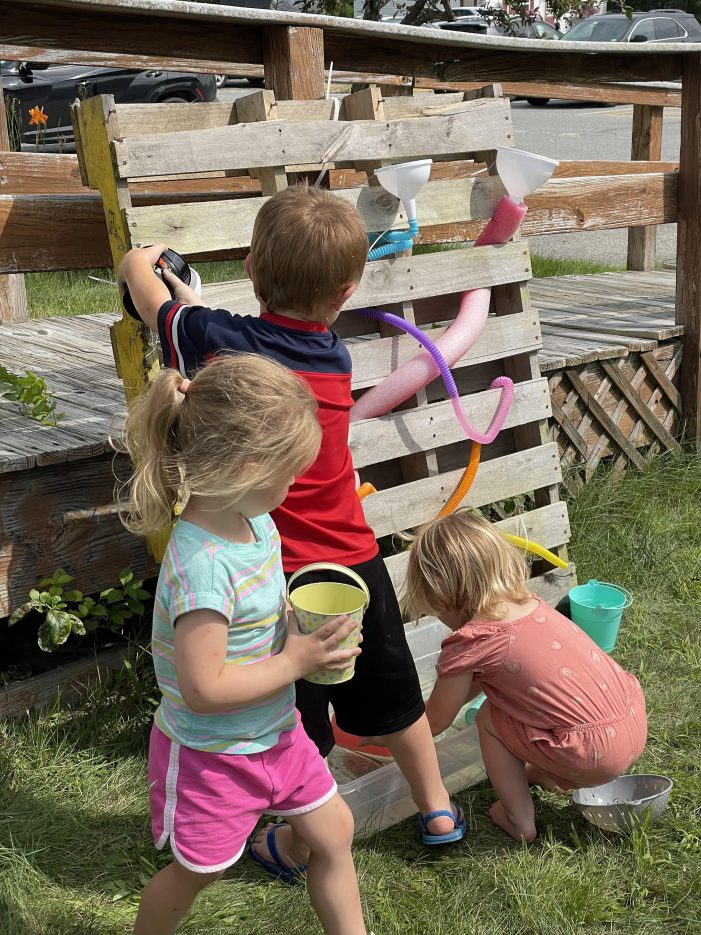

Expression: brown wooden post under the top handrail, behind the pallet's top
xmin=263 ymin=26 xmax=326 ymax=101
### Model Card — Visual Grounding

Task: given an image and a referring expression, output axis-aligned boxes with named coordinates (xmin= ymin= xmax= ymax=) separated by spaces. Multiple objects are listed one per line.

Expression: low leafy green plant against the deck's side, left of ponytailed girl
xmin=7 ymin=568 xmax=151 ymax=653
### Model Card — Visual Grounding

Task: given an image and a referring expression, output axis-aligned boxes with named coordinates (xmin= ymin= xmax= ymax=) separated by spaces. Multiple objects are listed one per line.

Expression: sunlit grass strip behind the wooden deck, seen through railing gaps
xmin=25 ymin=254 xmax=623 ymax=318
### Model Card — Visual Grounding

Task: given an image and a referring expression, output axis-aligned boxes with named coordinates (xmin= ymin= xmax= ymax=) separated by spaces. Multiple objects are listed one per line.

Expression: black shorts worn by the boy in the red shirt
xmin=287 ymin=555 xmax=424 ymax=756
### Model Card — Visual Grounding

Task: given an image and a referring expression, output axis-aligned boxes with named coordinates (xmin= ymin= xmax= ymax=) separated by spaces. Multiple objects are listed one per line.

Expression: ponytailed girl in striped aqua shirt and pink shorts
xmin=125 ymin=354 xmax=366 ymax=935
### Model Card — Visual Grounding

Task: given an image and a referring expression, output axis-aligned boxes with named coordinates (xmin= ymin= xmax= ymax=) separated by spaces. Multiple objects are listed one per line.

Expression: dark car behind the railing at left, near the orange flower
xmin=0 ymin=61 xmax=217 ymax=152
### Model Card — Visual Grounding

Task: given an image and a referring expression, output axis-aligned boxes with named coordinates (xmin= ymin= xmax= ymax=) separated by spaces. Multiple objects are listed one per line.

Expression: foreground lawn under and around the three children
xmin=0 ymin=457 xmax=701 ymax=935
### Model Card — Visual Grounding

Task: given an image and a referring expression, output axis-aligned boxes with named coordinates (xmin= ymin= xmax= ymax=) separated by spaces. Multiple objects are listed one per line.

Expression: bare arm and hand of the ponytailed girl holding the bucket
xmin=175 ymin=610 xmax=360 ymax=714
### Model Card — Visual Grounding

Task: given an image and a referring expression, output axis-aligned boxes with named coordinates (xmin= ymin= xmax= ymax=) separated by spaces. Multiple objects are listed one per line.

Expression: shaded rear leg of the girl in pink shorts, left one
xmin=134 ymin=860 xmax=224 ymax=935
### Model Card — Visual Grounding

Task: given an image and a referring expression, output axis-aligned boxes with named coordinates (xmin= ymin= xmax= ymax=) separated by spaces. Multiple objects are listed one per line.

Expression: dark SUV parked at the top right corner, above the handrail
xmin=562 ymin=10 xmax=701 ymax=42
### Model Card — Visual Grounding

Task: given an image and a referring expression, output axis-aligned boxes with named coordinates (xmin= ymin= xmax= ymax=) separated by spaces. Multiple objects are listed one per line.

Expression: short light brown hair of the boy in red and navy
xmin=250 ymin=185 xmax=368 ymax=321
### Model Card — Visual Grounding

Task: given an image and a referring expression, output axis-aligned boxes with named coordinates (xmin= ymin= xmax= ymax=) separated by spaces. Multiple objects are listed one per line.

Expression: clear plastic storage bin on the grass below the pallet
xmin=329 ymin=617 xmax=485 ymax=836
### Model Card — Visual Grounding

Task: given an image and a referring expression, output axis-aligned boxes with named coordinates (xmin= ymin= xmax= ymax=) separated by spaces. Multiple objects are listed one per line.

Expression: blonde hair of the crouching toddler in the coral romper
xmin=402 ymin=510 xmax=530 ymax=621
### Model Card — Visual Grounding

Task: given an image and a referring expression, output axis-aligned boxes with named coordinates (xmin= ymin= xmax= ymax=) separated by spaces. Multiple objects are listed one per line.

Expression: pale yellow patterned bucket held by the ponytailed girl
xmin=287 ymin=562 xmax=370 ymax=685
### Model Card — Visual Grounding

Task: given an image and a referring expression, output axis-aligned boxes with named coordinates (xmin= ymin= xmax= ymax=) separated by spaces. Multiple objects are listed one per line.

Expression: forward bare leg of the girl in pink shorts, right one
xmin=287 ymin=793 xmax=366 ymax=935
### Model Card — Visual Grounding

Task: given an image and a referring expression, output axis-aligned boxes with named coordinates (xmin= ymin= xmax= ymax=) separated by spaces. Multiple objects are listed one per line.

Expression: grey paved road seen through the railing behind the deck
xmin=219 ymin=86 xmax=681 ymax=266
